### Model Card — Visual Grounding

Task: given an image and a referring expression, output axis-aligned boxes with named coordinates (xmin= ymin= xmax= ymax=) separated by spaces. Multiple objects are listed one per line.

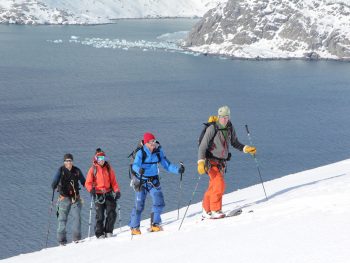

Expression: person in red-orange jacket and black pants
xmin=85 ymin=148 xmax=120 ymax=238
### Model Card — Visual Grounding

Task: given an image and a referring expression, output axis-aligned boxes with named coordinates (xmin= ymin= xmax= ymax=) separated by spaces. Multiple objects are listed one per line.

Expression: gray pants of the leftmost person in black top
xmin=57 ymin=197 xmax=83 ymax=243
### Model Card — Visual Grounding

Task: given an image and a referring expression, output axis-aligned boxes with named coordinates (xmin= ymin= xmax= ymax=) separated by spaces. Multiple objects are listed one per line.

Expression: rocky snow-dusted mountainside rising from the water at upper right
xmin=186 ymin=0 xmax=350 ymax=60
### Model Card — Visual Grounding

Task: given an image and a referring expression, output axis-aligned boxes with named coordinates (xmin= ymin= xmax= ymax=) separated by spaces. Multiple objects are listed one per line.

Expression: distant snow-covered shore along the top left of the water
xmin=0 ymin=0 xmax=227 ymax=24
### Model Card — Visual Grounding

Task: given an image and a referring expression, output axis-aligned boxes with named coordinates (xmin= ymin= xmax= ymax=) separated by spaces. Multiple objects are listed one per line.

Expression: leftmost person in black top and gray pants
xmin=51 ymin=153 xmax=85 ymax=245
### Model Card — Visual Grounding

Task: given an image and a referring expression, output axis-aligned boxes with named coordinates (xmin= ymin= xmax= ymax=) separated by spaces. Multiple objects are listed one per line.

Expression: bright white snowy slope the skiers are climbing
xmin=2 ymin=159 xmax=350 ymax=263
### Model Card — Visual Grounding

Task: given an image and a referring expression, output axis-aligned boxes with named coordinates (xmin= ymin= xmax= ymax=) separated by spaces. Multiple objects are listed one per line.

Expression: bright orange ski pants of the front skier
xmin=202 ymin=162 xmax=225 ymax=212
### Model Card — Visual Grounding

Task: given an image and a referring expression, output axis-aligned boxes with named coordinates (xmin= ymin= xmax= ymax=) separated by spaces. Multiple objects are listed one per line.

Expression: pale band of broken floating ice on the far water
xmin=47 ymin=31 xmax=199 ymax=56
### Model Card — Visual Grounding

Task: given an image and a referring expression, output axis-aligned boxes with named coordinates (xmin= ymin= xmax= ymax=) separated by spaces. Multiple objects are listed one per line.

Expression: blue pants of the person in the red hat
xmin=129 ymin=186 xmax=165 ymax=228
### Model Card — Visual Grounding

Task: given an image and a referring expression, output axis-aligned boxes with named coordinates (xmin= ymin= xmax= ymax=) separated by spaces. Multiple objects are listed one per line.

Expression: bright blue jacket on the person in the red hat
xmin=132 ymin=145 xmax=179 ymax=177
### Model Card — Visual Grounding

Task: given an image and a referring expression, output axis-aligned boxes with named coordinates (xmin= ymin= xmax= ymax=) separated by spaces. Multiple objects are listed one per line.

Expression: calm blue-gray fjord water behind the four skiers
xmin=0 ymin=19 xmax=350 ymax=259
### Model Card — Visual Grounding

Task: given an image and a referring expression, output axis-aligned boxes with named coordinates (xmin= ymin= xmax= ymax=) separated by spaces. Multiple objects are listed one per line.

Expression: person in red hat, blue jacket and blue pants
xmin=129 ymin=132 xmax=185 ymax=235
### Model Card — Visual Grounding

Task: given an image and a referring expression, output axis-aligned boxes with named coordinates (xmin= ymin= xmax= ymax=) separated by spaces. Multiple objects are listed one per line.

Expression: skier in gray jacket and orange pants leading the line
xmin=198 ymin=106 xmax=256 ymax=219
